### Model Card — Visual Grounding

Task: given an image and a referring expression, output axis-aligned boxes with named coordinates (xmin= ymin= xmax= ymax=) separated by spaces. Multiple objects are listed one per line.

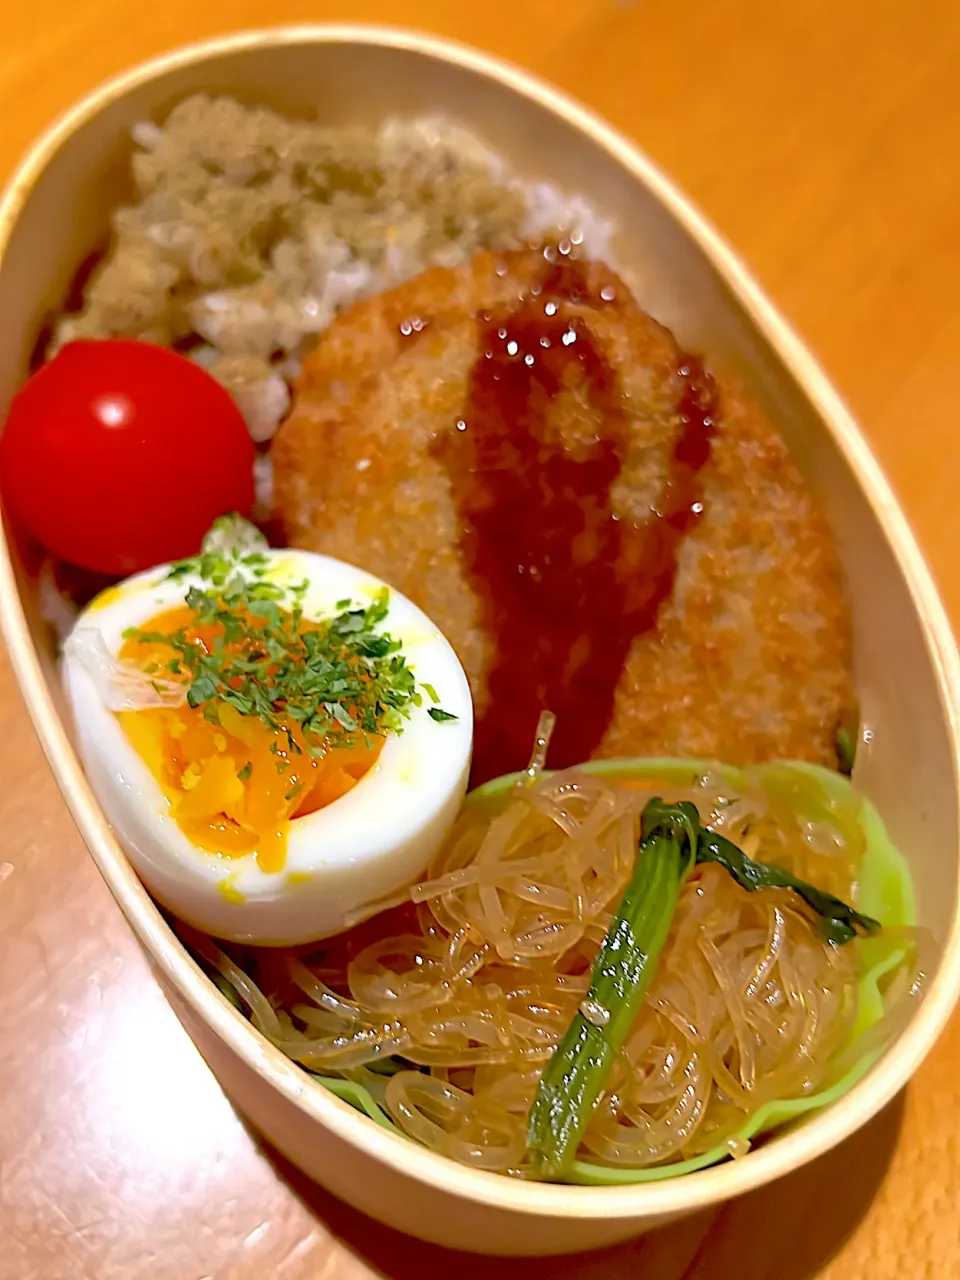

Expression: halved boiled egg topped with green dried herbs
xmin=64 ymin=548 xmax=472 ymax=946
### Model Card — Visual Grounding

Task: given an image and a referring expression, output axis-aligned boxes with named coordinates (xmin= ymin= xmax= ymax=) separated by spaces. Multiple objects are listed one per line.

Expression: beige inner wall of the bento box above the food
xmin=0 ymin=30 xmax=957 ymax=1049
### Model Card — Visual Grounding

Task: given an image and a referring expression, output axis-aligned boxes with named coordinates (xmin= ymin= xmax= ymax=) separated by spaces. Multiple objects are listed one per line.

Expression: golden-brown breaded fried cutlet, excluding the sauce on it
xmin=273 ymin=251 xmax=852 ymax=771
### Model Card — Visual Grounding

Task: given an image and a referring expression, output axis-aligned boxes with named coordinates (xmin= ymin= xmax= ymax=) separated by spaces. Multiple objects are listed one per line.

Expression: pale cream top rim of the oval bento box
xmin=0 ymin=23 xmax=960 ymax=1221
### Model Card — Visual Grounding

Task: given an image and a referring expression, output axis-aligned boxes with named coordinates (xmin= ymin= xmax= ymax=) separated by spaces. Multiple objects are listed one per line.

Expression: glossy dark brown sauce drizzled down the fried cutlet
xmin=438 ymin=251 xmax=717 ymax=785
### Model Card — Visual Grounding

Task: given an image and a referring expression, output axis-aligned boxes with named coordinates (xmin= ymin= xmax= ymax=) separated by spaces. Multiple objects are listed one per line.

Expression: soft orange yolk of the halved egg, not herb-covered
xmin=118 ymin=607 xmax=384 ymax=872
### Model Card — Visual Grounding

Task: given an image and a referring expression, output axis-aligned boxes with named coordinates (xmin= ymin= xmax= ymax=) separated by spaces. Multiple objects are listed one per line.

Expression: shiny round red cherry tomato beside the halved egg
xmin=0 ymin=338 xmax=253 ymax=576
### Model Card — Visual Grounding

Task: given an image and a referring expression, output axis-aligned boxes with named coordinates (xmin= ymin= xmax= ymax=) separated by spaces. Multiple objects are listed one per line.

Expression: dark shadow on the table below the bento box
xmin=259 ymin=1093 xmax=904 ymax=1280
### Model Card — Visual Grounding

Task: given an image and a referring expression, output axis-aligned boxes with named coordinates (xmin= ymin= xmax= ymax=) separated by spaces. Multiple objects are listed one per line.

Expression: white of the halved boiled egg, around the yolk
xmin=64 ymin=550 xmax=472 ymax=946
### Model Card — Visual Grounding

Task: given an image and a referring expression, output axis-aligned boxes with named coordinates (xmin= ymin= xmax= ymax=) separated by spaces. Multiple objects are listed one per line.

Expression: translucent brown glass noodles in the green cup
xmin=191 ymin=747 xmax=926 ymax=1175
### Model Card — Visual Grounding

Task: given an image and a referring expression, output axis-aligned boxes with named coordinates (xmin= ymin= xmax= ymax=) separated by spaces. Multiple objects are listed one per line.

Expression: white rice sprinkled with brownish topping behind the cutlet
xmin=55 ymin=96 xmax=613 ymax=445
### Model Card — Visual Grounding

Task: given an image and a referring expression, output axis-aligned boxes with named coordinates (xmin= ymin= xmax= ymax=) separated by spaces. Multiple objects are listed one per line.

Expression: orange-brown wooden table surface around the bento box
xmin=0 ymin=0 xmax=960 ymax=1280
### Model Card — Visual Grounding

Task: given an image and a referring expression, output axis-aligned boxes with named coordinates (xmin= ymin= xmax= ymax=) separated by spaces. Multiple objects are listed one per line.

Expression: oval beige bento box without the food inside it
xmin=0 ymin=26 xmax=960 ymax=1254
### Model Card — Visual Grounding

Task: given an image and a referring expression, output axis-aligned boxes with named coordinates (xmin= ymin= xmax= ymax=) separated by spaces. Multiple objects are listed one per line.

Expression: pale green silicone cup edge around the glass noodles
xmin=311 ymin=759 xmax=915 ymax=1187
